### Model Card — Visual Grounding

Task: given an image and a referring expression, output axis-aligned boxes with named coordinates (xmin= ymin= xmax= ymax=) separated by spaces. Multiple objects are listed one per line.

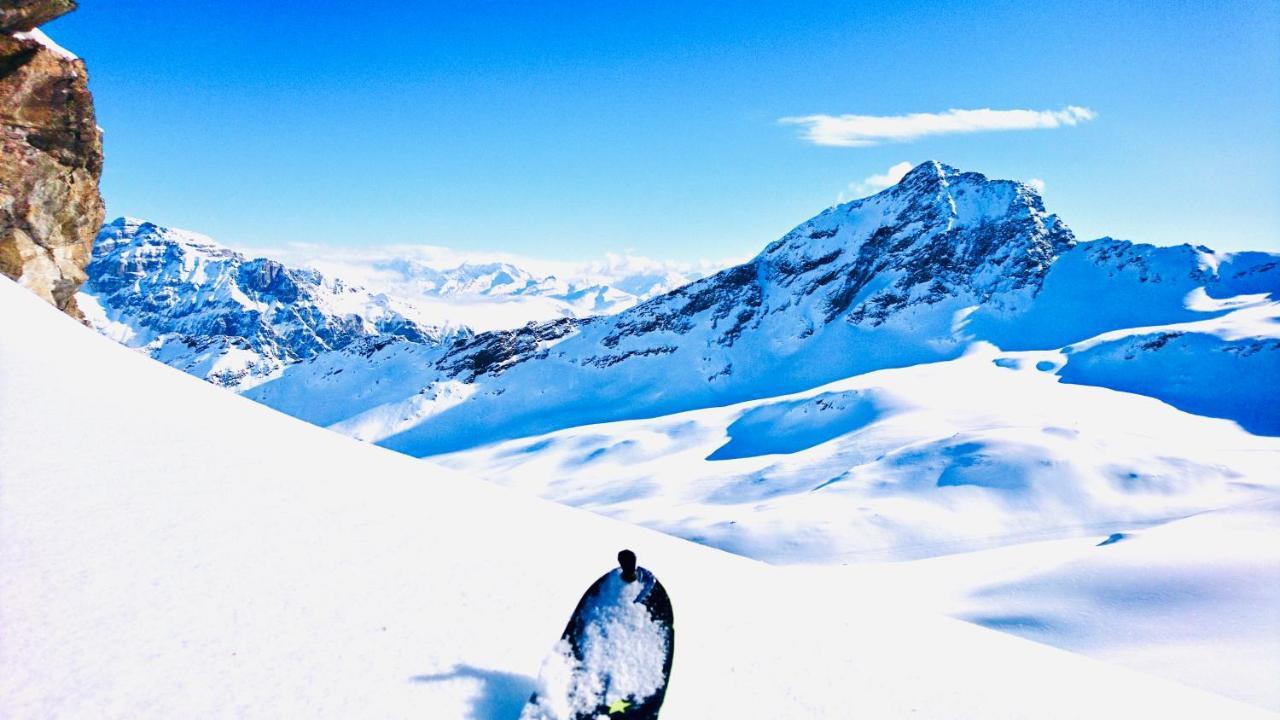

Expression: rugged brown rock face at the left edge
xmin=0 ymin=0 xmax=105 ymax=316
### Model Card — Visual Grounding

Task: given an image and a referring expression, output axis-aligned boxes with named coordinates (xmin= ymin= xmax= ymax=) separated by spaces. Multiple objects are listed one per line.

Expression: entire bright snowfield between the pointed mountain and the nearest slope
xmin=434 ymin=338 xmax=1280 ymax=708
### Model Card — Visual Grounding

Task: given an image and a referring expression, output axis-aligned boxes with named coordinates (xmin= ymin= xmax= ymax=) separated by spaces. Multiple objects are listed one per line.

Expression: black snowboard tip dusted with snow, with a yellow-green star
xmin=520 ymin=550 xmax=676 ymax=720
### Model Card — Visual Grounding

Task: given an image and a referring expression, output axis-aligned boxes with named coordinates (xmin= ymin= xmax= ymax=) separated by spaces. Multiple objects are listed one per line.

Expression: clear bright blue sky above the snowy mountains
xmin=45 ymin=0 xmax=1280 ymax=260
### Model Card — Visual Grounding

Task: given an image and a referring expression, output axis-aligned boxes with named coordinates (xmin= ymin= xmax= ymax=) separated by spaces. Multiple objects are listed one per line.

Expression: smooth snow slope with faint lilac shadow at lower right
xmin=858 ymin=500 xmax=1280 ymax=710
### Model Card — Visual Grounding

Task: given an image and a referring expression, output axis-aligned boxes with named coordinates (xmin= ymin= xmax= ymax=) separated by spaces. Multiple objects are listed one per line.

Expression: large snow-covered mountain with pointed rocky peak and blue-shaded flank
xmin=248 ymin=161 xmax=1280 ymax=456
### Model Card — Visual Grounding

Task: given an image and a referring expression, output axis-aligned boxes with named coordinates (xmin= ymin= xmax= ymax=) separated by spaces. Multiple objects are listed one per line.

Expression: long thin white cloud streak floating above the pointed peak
xmin=778 ymin=105 xmax=1097 ymax=147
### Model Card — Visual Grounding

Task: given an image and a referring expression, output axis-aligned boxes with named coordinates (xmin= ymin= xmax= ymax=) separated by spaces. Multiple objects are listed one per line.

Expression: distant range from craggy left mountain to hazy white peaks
xmin=78 ymin=218 xmax=721 ymax=391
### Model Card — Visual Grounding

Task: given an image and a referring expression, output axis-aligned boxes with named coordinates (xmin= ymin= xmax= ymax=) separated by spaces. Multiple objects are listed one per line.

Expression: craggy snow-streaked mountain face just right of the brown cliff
xmin=81 ymin=218 xmax=467 ymax=389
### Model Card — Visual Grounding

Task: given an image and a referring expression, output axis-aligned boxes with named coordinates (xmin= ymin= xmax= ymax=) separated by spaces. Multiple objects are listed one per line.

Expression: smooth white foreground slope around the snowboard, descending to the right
xmin=0 ymin=281 xmax=1274 ymax=720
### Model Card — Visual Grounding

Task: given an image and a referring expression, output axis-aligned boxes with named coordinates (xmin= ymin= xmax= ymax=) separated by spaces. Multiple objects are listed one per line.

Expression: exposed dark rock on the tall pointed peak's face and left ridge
xmin=427 ymin=163 xmax=1075 ymax=380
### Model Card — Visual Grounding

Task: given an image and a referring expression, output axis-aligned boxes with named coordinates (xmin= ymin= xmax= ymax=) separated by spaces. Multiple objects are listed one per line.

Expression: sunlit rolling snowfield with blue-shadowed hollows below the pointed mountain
xmin=434 ymin=346 xmax=1280 ymax=564
